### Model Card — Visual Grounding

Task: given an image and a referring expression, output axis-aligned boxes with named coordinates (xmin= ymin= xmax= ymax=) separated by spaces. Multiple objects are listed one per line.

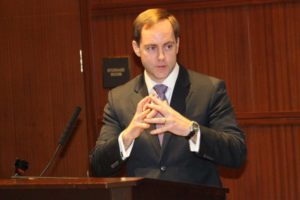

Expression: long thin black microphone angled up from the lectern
xmin=40 ymin=106 xmax=81 ymax=176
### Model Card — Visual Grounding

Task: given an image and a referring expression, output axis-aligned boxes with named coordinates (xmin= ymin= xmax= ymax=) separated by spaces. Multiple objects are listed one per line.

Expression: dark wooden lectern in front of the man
xmin=0 ymin=177 xmax=228 ymax=200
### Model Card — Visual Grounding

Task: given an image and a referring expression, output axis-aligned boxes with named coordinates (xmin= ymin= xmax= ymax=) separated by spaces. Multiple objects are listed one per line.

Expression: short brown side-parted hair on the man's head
xmin=133 ymin=8 xmax=179 ymax=44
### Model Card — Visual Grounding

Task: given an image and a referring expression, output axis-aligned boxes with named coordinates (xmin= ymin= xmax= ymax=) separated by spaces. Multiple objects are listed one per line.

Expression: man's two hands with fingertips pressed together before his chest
xmin=123 ymin=95 xmax=192 ymax=146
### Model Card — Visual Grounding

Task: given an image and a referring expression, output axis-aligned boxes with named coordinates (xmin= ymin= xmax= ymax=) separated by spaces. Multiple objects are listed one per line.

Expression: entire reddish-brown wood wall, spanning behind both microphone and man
xmin=0 ymin=0 xmax=300 ymax=200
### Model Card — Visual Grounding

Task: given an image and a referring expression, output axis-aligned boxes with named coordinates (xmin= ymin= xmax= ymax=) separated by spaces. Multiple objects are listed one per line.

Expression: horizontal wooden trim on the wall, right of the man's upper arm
xmin=237 ymin=111 xmax=300 ymax=126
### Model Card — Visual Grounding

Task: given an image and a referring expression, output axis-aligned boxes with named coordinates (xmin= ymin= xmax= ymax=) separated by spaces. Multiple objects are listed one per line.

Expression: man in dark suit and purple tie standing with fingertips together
xmin=91 ymin=9 xmax=246 ymax=186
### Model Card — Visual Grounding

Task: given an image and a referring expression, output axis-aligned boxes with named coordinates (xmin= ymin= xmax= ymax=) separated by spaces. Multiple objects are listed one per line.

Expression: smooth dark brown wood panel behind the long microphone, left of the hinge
xmin=0 ymin=0 xmax=88 ymax=178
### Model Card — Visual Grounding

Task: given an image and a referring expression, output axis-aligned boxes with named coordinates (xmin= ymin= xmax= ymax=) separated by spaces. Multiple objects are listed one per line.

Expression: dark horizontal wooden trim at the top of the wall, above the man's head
xmin=92 ymin=0 xmax=297 ymax=17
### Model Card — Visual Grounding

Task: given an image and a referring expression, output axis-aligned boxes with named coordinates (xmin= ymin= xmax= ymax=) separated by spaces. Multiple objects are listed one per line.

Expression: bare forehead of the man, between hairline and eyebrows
xmin=141 ymin=20 xmax=175 ymax=43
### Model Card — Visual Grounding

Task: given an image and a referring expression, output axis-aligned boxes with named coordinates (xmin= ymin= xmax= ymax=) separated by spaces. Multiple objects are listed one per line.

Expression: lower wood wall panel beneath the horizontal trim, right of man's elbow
xmin=221 ymin=125 xmax=300 ymax=200
